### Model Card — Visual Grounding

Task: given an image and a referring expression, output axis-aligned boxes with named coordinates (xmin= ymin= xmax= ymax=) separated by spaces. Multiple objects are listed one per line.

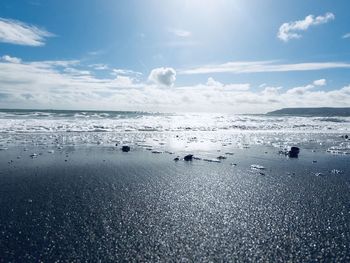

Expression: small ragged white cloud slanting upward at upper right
xmin=277 ymin=13 xmax=335 ymax=42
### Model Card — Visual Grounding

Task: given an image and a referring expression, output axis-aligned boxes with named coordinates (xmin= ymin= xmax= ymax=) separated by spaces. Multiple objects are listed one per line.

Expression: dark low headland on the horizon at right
xmin=266 ymin=107 xmax=350 ymax=117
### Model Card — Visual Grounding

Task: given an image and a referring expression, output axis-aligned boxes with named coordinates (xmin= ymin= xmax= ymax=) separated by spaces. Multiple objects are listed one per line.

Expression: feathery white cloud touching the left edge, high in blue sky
xmin=0 ymin=18 xmax=53 ymax=46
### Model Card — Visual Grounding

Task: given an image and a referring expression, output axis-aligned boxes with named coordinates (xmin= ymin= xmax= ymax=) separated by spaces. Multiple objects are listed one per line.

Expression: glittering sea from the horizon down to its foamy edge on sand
xmin=0 ymin=110 xmax=350 ymax=157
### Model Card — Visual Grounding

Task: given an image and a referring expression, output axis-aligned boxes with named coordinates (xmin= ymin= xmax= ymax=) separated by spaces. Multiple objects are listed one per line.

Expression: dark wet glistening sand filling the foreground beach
xmin=0 ymin=146 xmax=350 ymax=262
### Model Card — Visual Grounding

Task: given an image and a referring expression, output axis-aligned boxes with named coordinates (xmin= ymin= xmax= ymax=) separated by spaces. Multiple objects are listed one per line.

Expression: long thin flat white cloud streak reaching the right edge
xmin=179 ymin=61 xmax=350 ymax=74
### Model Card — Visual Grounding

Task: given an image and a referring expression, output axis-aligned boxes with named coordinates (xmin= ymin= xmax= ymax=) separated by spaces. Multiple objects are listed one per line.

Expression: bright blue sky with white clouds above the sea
xmin=0 ymin=0 xmax=350 ymax=113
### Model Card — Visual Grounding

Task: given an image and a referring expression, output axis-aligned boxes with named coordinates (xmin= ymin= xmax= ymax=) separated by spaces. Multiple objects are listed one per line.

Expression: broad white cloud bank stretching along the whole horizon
xmin=0 ymin=55 xmax=350 ymax=113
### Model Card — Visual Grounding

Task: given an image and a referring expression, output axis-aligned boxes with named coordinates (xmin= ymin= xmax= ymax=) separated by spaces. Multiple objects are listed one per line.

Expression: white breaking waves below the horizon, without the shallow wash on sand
xmin=0 ymin=110 xmax=350 ymax=133
